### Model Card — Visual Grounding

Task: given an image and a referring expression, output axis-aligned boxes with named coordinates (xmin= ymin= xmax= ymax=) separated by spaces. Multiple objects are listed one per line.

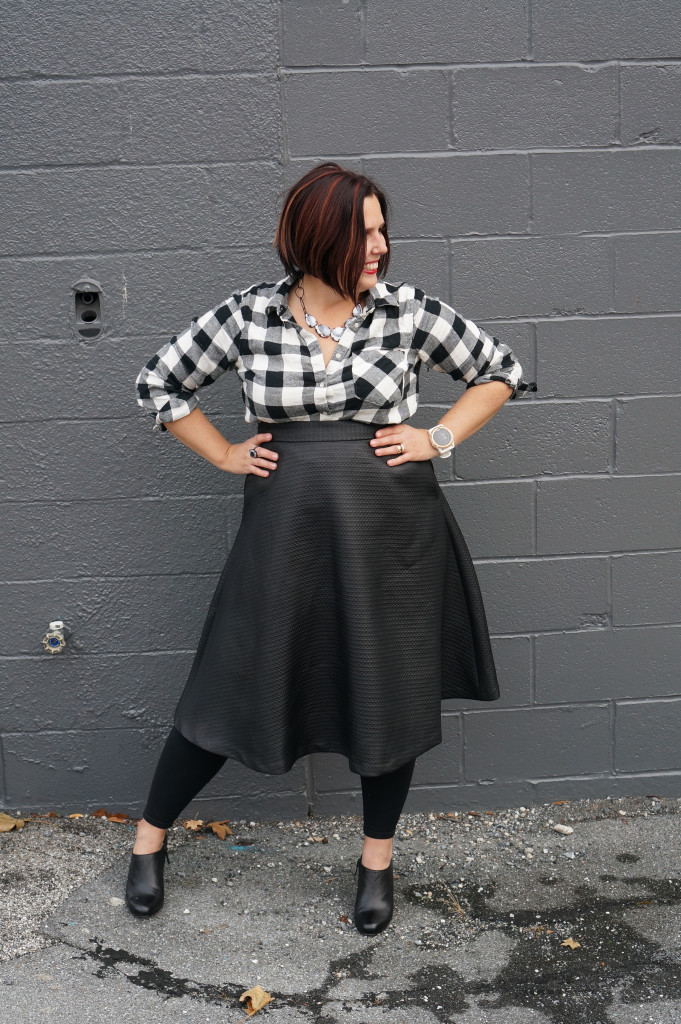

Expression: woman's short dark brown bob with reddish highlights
xmin=272 ymin=161 xmax=390 ymax=302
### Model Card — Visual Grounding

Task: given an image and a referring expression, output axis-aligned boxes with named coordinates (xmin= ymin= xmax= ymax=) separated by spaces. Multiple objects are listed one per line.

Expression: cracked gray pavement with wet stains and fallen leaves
xmin=0 ymin=797 xmax=681 ymax=1024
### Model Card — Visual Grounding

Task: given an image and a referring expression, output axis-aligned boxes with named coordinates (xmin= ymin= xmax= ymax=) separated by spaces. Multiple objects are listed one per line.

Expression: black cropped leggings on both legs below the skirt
xmin=142 ymin=726 xmax=416 ymax=839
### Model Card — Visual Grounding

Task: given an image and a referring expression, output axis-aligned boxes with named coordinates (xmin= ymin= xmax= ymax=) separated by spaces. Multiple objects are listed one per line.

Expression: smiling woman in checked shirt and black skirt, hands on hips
xmin=126 ymin=162 xmax=536 ymax=934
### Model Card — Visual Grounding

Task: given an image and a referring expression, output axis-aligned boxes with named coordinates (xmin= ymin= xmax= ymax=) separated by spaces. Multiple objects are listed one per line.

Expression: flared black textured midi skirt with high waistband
xmin=174 ymin=420 xmax=500 ymax=775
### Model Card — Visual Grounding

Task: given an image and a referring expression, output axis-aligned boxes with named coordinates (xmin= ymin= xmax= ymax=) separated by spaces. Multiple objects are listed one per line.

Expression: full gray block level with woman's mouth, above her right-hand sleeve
xmin=451 ymin=236 xmax=610 ymax=319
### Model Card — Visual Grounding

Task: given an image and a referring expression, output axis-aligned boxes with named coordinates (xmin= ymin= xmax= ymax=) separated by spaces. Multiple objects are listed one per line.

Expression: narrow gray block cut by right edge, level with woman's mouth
xmin=612 ymin=231 xmax=681 ymax=313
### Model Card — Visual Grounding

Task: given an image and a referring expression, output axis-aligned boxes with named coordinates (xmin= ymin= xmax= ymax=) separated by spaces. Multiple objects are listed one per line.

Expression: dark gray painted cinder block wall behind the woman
xmin=0 ymin=0 xmax=681 ymax=818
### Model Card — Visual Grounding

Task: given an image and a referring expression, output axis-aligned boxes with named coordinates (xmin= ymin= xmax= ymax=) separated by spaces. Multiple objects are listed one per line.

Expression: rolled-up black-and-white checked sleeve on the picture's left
xmin=135 ymin=292 xmax=244 ymax=432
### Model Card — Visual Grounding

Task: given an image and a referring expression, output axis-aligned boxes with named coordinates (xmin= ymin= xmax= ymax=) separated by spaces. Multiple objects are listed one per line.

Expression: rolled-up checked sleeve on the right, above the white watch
xmin=413 ymin=289 xmax=537 ymax=398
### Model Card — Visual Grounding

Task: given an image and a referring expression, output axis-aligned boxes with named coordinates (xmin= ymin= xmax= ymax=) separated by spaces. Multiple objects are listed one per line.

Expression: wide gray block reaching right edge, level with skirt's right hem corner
xmin=535 ymin=626 xmax=681 ymax=703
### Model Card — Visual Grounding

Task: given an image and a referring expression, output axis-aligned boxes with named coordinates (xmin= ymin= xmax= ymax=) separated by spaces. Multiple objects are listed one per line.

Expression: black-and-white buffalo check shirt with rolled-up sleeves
xmin=135 ymin=274 xmax=537 ymax=431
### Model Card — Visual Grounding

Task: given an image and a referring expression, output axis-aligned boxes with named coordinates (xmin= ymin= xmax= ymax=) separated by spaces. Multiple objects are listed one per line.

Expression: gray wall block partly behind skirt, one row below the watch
xmin=442 ymin=481 xmax=535 ymax=558
